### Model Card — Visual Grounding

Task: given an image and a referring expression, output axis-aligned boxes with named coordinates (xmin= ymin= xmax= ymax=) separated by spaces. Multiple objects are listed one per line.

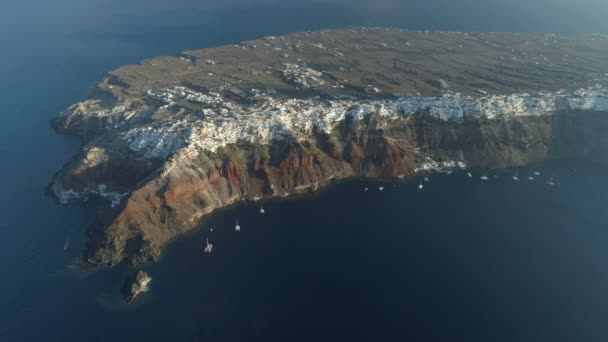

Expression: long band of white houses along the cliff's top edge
xmin=123 ymin=85 xmax=608 ymax=158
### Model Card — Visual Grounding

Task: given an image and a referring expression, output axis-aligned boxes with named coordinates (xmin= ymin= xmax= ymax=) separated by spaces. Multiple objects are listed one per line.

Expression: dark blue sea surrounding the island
xmin=0 ymin=0 xmax=608 ymax=342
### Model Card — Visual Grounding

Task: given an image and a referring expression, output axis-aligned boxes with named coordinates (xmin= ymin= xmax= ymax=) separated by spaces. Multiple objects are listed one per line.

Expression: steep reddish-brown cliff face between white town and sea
xmin=63 ymin=114 xmax=608 ymax=265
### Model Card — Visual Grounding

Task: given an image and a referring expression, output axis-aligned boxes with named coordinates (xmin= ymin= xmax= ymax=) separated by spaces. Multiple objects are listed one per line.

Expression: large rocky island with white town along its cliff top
xmin=49 ymin=28 xmax=608 ymax=266
